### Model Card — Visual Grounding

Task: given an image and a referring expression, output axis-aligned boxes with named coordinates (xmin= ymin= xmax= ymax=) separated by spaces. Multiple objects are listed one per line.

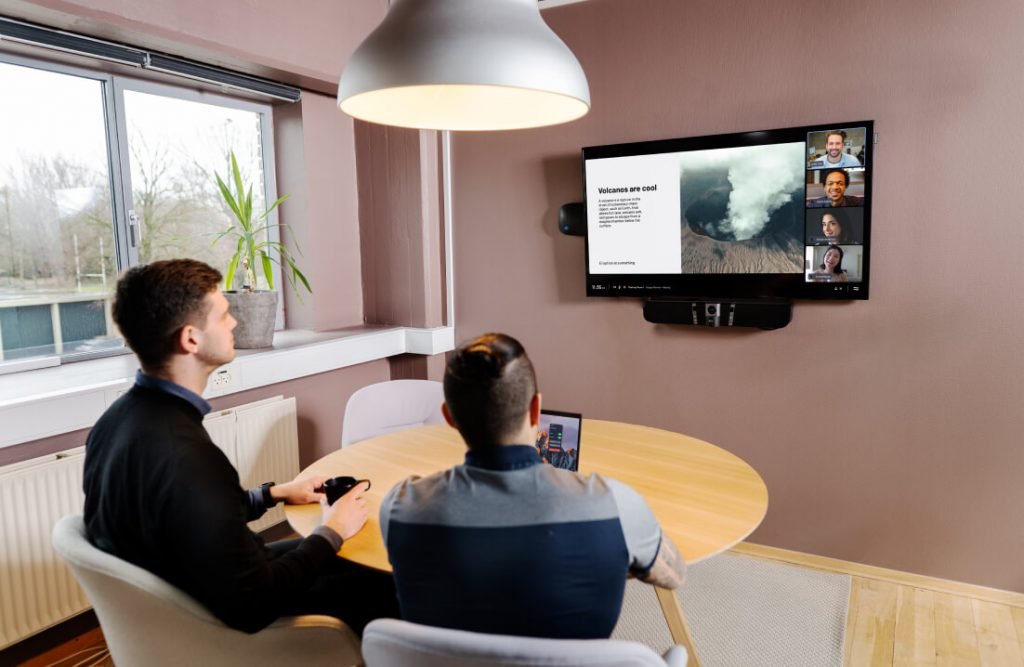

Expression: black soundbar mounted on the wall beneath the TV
xmin=643 ymin=299 xmax=793 ymax=330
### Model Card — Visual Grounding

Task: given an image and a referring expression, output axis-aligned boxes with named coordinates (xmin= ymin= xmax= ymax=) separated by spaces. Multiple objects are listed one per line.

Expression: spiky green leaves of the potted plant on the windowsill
xmin=210 ymin=151 xmax=313 ymax=295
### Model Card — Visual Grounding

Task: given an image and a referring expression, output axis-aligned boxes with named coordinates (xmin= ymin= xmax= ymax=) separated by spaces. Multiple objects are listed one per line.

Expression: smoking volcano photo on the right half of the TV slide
xmin=679 ymin=142 xmax=806 ymax=274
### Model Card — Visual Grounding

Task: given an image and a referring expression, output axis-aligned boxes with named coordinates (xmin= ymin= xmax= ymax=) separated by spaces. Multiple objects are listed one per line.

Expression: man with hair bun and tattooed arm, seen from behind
xmin=380 ymin=333 xmax=685 ymax=638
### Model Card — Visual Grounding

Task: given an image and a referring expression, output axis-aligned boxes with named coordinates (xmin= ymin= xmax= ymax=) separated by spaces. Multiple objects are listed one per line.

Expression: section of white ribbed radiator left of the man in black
xmin=0 ymin=447 xmax=89 ymax=649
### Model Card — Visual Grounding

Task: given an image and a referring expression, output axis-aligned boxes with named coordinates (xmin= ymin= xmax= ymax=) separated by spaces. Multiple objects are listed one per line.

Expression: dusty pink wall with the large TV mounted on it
xmin=455 ymin=0 xmax=1024 ymax=591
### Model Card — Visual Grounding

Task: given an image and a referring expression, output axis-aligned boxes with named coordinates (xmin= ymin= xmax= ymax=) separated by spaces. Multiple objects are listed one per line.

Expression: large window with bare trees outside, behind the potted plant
xmin=0 ymin=55 xmax=281 ymax=372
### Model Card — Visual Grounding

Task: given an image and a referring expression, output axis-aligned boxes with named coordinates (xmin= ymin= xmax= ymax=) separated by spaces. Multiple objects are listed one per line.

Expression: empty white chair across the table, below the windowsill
xmin=341 ymin=380 xmax=444 ymax=447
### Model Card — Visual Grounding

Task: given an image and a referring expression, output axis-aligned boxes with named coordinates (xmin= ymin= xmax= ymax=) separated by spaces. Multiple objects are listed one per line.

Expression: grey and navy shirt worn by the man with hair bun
xmin=380 ymin=445 xmax=662 ymax=638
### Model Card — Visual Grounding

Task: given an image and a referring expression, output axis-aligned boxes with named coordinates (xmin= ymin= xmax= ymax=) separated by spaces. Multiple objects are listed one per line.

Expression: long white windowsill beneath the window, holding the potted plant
xmin=0 ymin=325 xmax=455 ymax=448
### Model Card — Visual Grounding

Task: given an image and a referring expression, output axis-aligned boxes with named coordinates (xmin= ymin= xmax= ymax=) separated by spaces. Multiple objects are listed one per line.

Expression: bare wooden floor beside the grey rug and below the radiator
xmin=16 ymin=544 xmax=1024 ymax=667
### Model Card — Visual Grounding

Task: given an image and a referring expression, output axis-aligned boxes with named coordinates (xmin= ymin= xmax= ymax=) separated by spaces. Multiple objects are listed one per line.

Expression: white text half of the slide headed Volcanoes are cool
xmin=587 ymin=153 xmax=681 ymax=274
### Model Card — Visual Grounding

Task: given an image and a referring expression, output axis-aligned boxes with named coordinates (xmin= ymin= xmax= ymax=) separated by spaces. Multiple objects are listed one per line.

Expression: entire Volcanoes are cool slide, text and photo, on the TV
xmin=587 ymin=142 xmax=805 ymax=275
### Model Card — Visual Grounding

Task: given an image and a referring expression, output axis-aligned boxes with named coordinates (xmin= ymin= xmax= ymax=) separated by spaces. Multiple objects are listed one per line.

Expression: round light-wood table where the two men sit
xmin=285 ymin=419 xmax=768 ymax=665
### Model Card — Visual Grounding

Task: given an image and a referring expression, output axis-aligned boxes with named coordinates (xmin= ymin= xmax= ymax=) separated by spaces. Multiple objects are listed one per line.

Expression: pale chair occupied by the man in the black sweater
xmin=53 ymin=514 xmax=361 ymax=667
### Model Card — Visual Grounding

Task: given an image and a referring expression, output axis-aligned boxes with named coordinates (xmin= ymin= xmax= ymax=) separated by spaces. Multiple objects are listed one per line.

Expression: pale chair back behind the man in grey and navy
xmin=362 ymin=619 xmax=687 ymax=667
